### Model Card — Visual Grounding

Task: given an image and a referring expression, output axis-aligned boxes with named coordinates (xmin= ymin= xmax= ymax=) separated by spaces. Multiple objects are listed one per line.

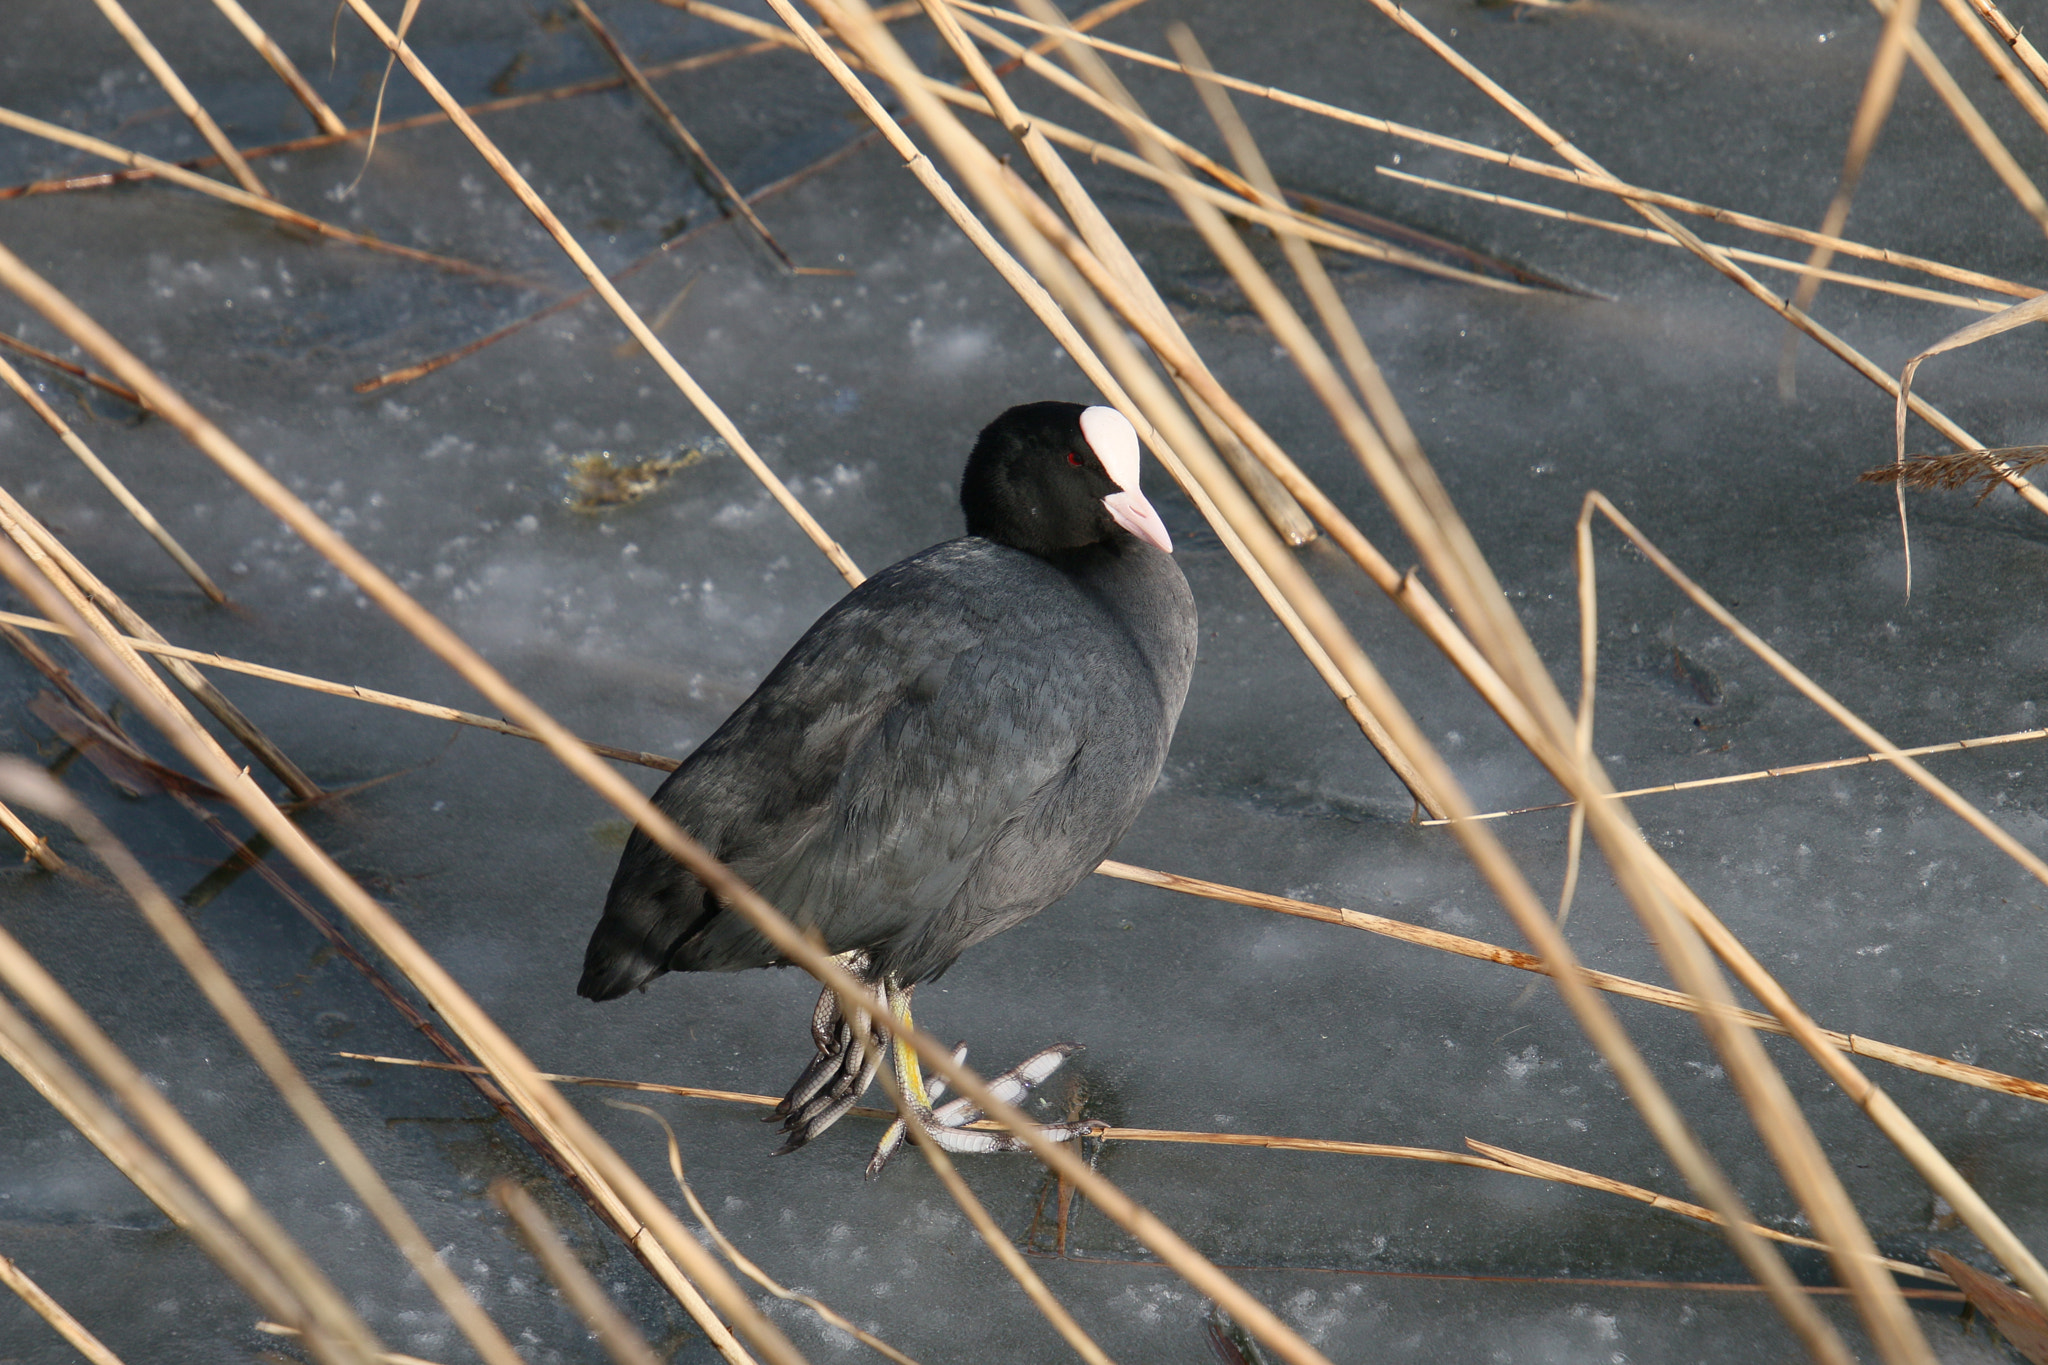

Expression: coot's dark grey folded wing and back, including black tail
xmin=580 ymin=540 xmax=1092 ymax=999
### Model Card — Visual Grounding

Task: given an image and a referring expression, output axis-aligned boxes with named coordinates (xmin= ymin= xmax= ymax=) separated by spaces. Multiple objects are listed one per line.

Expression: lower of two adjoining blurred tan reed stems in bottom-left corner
xmin=0 ymin=995 xmax=327 ymax=1342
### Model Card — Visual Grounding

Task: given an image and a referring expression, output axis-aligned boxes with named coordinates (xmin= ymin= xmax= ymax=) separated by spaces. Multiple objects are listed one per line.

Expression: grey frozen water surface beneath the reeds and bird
xmin=0 ymin=0 xmax=2048 ymax=1363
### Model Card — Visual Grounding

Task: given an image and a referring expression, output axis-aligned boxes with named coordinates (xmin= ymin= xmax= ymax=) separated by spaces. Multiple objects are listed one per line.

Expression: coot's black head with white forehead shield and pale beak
xmin=961 ymin=403 xmax=1174 ymax=555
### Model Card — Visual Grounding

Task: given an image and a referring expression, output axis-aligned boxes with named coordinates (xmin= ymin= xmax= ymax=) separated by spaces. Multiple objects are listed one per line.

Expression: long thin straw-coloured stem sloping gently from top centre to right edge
xmin=948 ymin=0 xmax=2042 ymax=299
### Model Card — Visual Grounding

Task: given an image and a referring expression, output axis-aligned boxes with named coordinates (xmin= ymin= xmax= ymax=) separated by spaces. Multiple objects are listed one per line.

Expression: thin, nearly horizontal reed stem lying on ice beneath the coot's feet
xmin=356 ymin=1052 xmax=1954 ymax=1285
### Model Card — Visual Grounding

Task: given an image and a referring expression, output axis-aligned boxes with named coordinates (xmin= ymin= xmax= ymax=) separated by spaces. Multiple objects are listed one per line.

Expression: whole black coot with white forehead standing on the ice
xmin=578 ymin=403 xmax=1196 ymax=1175
